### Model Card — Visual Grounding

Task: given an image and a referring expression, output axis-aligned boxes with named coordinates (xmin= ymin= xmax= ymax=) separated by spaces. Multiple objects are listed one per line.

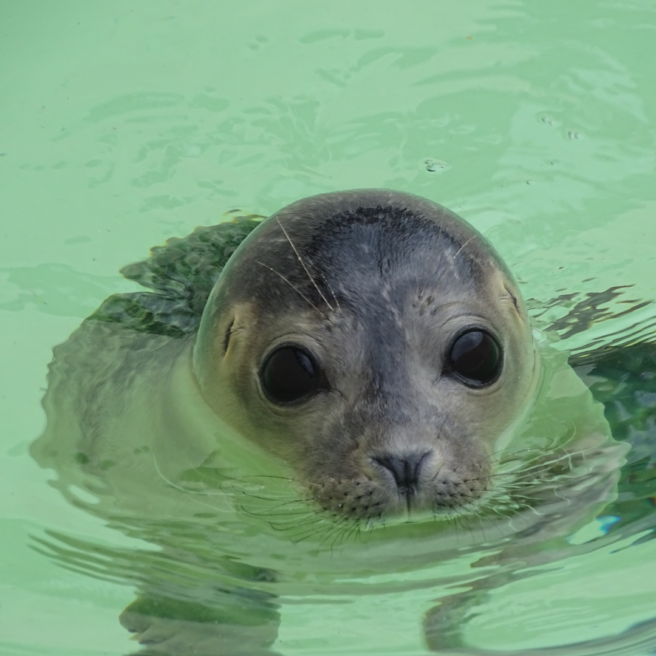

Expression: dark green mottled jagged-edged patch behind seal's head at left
xmin=88 ymin=215 xmax=263 ymax=337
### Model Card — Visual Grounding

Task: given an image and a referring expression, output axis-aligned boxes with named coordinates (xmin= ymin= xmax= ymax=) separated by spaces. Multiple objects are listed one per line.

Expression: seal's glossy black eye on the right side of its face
xmin=449 ymin=330 xmax=501 ymax=387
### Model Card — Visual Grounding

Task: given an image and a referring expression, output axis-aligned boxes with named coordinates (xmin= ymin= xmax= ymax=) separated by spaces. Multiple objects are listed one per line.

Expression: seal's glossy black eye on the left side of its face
xmin=260 ymin=346 xmax=319 ymax=403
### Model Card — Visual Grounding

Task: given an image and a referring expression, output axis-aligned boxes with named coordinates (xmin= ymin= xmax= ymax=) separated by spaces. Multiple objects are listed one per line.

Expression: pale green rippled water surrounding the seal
xmin=0 ymin=0 xmax=656 ymax=656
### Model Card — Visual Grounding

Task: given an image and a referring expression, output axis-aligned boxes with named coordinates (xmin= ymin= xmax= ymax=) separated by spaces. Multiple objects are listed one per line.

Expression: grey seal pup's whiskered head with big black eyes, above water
xmin=193 ymin=190 xmax=540 ymax=520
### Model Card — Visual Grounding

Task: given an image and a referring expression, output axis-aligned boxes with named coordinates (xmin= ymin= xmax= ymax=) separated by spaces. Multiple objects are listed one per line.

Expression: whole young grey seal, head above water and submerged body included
xmin=32 ymin=190 xmax=626 ymax=655
